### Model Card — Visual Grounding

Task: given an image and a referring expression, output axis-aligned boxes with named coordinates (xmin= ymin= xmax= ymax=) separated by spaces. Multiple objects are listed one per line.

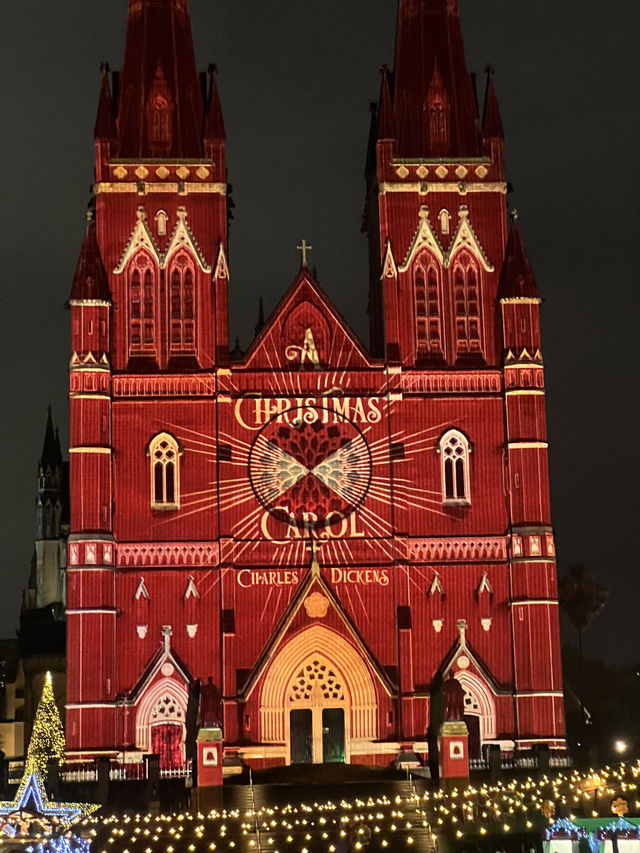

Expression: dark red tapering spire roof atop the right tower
xmin=394 ymin=0 xmax=479 ymax=157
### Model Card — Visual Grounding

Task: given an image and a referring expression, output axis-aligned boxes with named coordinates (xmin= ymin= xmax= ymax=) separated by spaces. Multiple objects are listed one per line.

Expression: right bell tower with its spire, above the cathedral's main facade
xmin=365 ymin=0 xmax=507 ymax=367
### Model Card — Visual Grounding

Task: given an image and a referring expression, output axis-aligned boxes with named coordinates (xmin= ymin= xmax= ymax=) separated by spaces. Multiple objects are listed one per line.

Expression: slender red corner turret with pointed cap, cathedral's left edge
xmin=67 ymin=212 xmax=116 ymax=724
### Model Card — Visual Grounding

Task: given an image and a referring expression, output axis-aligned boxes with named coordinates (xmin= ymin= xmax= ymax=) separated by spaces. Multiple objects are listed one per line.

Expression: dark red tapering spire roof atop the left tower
xmin=118 ymin=0 xmax=204 ymax=158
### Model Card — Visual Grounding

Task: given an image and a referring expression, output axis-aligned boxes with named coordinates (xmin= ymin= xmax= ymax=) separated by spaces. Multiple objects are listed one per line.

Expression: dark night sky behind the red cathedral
xmin=0 ymin=0 xmax=640 ymax=662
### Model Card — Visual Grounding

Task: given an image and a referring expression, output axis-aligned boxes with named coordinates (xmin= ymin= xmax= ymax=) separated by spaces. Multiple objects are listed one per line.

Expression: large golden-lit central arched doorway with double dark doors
xmin=260 ymin=625 xmax=378 ymax=764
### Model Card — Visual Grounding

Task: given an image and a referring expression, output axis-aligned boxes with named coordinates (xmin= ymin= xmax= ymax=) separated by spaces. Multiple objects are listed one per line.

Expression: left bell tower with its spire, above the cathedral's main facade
xmin=94 ymin=0 xmax=228 ymax=373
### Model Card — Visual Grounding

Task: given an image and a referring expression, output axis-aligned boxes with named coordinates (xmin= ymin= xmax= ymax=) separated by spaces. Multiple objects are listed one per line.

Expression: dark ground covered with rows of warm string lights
xmin=74 ymin=762 xmax=640 ymax=853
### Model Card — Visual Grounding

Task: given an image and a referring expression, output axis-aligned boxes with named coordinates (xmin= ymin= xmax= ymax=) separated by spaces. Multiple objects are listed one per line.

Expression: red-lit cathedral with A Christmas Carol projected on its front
xmin=66 ymin=0 xmax=564 ymax=767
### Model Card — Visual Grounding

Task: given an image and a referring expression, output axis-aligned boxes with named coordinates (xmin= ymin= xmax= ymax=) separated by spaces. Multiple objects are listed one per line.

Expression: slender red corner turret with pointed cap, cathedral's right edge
xmin=498 ymin=220 xmax=563 ymax=732
